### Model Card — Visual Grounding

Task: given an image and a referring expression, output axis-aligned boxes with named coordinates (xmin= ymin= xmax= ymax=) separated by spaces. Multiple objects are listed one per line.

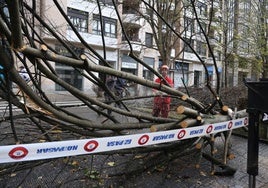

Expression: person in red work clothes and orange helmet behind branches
xmin=152 ymin=65 xmax=174 ymax=118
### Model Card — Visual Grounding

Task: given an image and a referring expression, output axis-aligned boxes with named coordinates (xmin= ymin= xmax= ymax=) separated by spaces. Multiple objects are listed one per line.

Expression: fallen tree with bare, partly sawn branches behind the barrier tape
xmin=0 ymin=1 xmax=247 ymax=179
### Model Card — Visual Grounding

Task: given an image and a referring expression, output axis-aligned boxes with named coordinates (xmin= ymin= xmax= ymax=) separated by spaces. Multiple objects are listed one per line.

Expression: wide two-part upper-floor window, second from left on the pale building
xmin=92 ymin=14 xmax=117 ymax=38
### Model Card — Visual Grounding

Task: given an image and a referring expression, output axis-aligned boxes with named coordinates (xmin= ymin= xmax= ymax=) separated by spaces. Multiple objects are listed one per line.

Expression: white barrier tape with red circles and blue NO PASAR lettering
xmin=0 ymin=117 xmax=248 ymax=163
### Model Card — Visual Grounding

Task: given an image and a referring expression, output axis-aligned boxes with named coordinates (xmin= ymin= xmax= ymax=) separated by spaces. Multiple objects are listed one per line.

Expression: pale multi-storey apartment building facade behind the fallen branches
xmin=31 ymin=0 xmax=253 ymax=93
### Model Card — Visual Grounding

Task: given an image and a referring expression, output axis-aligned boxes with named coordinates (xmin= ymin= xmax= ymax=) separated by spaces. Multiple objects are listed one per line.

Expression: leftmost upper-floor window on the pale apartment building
xmin=67 ymin=8 xmax=88 ymax=32
